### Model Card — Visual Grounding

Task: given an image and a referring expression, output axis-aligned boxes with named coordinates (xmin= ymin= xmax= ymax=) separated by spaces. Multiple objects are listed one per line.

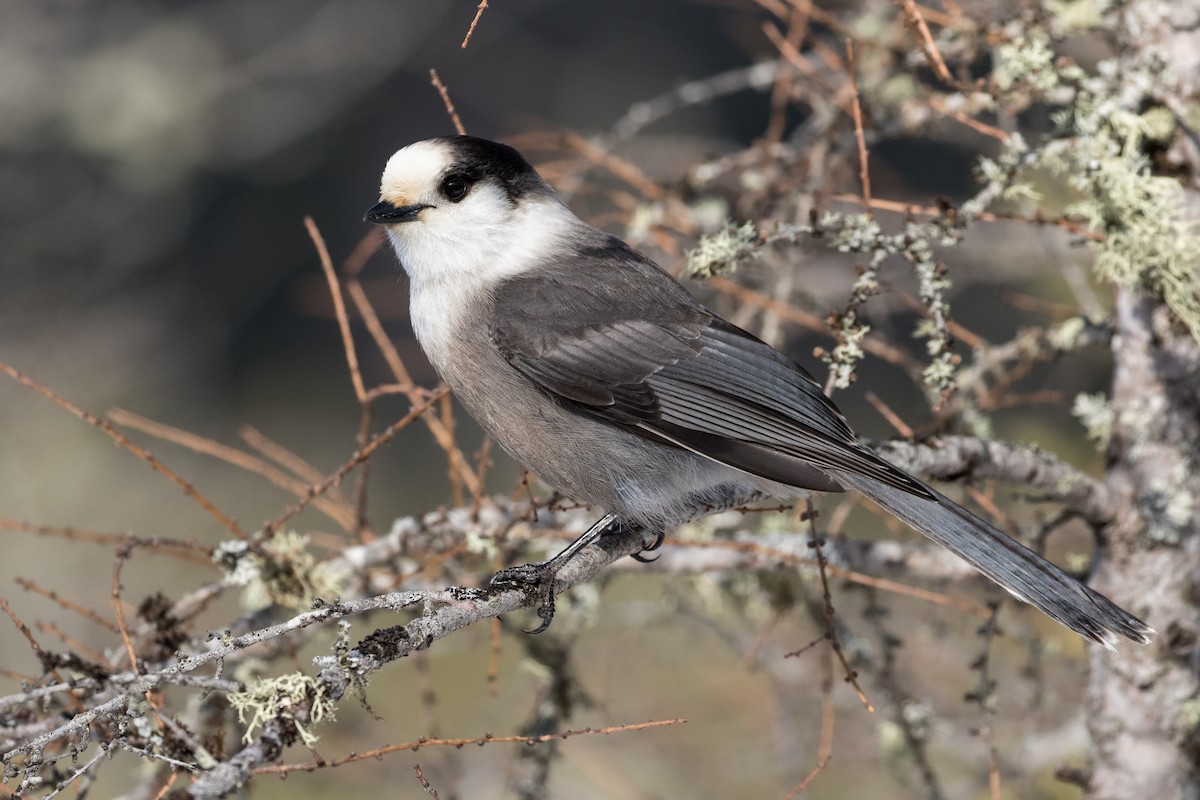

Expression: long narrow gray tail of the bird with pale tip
xmin=829 ymin=470 xmax=1154 ymax=650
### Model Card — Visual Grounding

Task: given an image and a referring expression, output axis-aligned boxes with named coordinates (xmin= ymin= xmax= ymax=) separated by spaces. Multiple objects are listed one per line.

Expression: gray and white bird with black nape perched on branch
xmin=365 ymin=136 xmax=1152 ymax=648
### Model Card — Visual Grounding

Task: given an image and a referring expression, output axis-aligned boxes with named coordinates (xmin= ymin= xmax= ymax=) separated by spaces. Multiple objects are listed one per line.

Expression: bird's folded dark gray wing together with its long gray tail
xmin=492 ymin=240 xmax=1152 ymax=648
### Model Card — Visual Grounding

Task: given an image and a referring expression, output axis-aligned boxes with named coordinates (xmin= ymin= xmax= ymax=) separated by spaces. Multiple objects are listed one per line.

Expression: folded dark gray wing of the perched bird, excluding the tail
xmin=492 ymin=240 xmax=928 ymax=497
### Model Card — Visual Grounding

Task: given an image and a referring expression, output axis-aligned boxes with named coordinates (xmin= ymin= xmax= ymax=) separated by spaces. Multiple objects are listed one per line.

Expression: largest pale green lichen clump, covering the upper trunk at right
xmin=984 ymin=27 xmax=1200 ymax=341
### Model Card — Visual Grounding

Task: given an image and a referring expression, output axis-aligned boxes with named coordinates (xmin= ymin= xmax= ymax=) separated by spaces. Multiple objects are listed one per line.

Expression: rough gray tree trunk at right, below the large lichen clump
xmin=1087 ymin=291 xmax=1200 ymax=800
